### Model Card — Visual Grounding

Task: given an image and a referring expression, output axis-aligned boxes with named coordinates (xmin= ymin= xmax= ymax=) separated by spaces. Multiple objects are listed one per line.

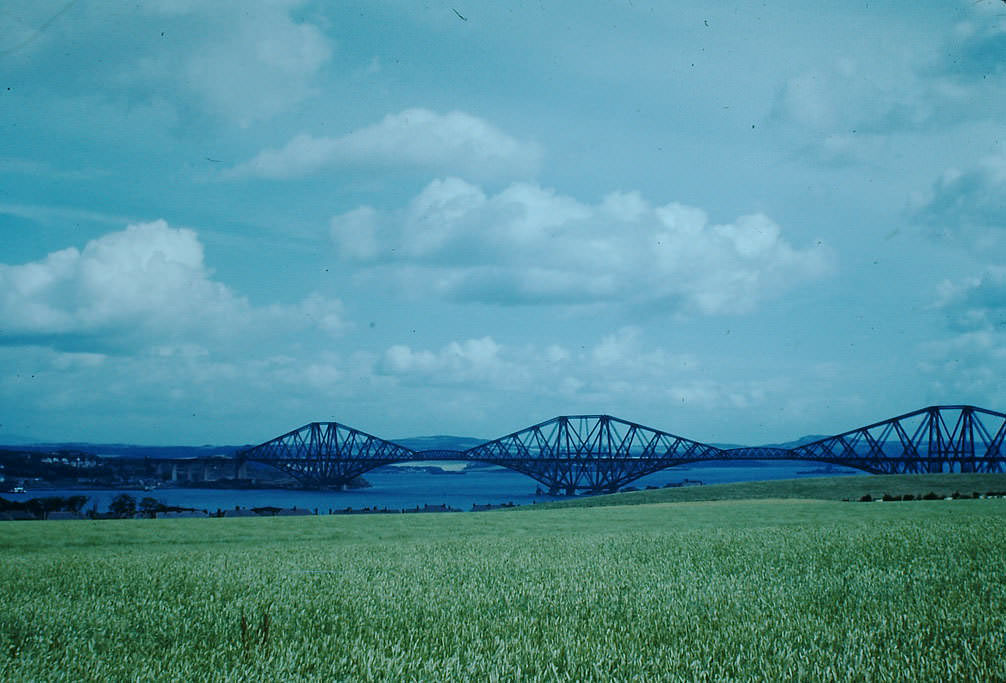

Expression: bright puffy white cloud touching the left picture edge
xmin=0 ymin=220 xmax=344 ymax=348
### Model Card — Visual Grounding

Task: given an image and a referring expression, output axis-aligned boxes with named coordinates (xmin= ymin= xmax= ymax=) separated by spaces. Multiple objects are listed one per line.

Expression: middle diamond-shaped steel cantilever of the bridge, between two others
xmin=465 ymin=415 xmax=720 ymax=494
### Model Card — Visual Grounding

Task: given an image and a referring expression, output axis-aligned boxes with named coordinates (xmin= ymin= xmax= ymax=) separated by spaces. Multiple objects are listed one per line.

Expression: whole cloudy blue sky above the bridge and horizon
xmin=0 ymin=0 xmax=1006 ymax=445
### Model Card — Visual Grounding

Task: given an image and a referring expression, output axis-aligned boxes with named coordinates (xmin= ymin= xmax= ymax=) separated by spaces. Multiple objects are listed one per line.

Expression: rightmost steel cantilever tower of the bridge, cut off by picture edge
xmin=792 ymin=405 xmax=1006 ymax=474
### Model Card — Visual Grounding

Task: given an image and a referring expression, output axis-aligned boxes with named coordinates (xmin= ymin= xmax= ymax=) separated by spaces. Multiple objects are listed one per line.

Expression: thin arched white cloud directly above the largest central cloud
xmin=228 ymin=109 xmax=541 ymax=178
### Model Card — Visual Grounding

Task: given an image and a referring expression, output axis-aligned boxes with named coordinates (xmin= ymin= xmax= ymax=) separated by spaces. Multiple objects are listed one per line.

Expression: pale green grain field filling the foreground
xmin=0 ymin=478 xmax=1006 ymax=681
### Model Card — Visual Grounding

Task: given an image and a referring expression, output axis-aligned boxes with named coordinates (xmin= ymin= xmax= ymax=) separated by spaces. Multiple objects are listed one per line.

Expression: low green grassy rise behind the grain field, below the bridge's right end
xmin=531 ymin=474 xmax=1006 ymax=510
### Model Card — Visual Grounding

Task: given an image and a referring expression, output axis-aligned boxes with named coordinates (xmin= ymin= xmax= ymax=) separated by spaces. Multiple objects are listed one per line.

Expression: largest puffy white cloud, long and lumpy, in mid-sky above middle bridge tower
xmin=331 ymin=178 xmax=830 ymax=314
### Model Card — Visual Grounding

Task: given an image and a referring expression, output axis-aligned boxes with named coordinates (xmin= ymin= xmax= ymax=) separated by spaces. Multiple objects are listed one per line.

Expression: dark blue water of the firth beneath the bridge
xmin=0 ymin=462 xmax=861 ymax=513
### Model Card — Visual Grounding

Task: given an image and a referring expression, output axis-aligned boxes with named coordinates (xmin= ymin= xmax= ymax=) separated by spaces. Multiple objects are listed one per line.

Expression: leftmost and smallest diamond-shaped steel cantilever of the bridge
xmin=237 ymin=422 xmax=414 ymax=486
